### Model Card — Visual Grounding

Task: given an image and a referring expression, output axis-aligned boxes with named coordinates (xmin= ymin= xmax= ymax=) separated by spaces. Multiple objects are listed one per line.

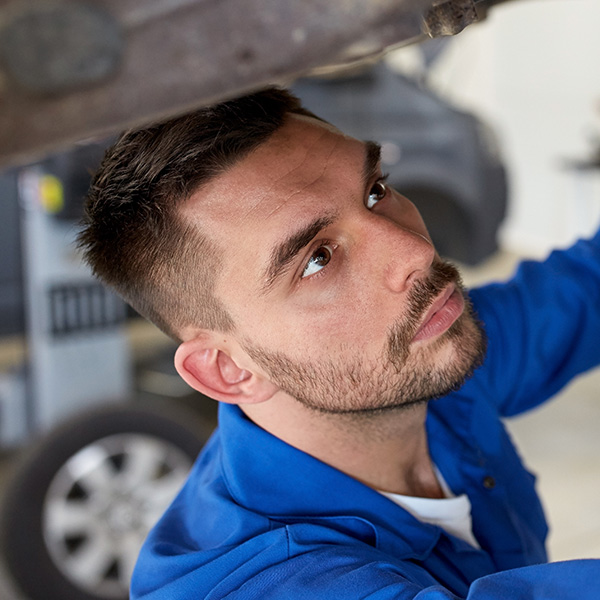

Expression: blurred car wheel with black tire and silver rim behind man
xmin=0 ymin=405 xmax=210 ymax=600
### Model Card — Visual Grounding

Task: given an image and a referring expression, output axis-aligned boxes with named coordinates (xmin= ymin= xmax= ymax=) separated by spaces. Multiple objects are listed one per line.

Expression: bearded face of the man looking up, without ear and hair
xmin=183 ymin=116 xmax=484 ymax=414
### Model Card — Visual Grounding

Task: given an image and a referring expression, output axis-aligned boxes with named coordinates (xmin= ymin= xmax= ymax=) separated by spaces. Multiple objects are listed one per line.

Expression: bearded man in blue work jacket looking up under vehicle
xmin=80 ymin=89 xmax=600 ymax=600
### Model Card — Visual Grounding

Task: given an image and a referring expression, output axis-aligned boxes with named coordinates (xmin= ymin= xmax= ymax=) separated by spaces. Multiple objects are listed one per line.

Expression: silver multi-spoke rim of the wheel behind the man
xmin=42 ymin=433 xmax=192 ymax=598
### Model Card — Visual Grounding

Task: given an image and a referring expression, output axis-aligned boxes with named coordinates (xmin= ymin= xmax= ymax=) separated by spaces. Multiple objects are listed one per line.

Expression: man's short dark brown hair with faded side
xmin=78 ymin=88 xmax=314 ymax=339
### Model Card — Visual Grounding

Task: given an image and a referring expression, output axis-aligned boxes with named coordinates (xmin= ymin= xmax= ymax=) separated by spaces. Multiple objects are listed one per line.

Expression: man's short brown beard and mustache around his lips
xmin=244 ymin=261 xmax=486 ymax=416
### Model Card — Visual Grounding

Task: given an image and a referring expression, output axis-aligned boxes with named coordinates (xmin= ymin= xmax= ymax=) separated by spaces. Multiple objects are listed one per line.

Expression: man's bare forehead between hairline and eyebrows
xmin=182 ymin=115 xmax=365 ymax=292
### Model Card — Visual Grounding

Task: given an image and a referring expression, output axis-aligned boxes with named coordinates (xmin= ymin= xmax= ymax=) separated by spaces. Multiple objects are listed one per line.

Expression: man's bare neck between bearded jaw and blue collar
xmin=242 ymin=393 xmax=443 ymax=498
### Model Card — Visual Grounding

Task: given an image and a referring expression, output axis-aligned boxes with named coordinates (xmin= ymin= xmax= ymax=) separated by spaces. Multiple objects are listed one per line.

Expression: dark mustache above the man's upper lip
xmin=388 ymin=260 xmax=463 ymax=360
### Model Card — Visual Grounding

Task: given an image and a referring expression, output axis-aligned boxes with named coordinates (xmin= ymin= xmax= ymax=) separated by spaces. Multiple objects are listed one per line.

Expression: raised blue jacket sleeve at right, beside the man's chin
xmin=467 ymin=231 xmax=600 ymax=416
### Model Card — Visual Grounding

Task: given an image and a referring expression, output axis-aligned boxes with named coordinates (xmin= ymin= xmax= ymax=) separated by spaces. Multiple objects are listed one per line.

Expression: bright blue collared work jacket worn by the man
xmin=132 ymin=229 xmax=600 ymax=600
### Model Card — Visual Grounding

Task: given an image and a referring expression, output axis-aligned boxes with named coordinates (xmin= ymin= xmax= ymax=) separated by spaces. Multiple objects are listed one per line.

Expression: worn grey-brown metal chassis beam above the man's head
xmin=0 ymin=0 xmax=476 ymax=165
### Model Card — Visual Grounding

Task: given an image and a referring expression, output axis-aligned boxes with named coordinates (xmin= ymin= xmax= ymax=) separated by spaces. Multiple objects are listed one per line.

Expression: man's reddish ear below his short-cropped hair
xmin=175 ymin=337 xmax=279 ymax=404
